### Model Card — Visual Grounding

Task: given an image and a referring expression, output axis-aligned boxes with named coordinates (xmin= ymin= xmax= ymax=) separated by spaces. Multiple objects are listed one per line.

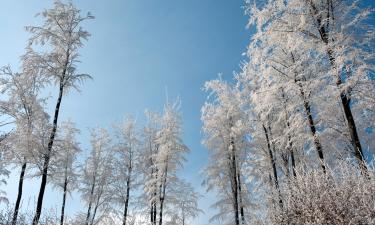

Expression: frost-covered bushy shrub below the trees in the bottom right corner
xmin=266 ymin=163 xmax=375 ymax=225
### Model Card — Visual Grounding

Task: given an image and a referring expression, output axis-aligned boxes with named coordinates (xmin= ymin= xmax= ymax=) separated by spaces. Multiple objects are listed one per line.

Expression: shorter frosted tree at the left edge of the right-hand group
xmin=202 ymin=80 xmax=250 ymax=225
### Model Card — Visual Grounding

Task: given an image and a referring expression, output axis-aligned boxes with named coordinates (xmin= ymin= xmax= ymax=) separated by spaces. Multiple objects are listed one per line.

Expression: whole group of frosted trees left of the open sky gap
xmin=0 ymin=0 xmax=202 ymax=225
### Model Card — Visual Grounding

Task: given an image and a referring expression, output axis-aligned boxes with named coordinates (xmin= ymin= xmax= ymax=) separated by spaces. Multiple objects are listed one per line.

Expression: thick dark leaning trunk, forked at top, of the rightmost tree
xmin=310 ymin=0 xmax=367 ymax=174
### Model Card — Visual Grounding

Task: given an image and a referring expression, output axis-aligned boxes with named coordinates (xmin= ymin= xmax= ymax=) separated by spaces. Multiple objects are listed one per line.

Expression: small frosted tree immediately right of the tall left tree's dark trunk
xmin=50 ymin=120 xmax=81 ymax=225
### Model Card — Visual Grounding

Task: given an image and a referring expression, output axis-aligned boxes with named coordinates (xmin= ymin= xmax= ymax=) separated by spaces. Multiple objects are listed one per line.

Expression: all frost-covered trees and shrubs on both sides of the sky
xmin=0 ymin=0 xmax=375 ymax=225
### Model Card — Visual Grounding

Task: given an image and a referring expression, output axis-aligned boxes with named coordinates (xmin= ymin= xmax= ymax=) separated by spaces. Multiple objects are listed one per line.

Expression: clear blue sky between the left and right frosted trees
xmin=0 ymin=0 xmax=251 ymax=225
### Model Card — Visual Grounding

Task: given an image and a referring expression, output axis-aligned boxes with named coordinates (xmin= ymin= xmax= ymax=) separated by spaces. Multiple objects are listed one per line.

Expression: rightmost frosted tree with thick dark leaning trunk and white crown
xmin=298 ymin=0 xmax=375 ymax=171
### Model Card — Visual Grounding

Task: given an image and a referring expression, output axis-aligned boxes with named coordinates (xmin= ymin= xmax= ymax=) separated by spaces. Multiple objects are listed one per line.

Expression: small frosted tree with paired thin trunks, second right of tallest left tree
xmin=80 ymin=128 xmax=114 ymax=225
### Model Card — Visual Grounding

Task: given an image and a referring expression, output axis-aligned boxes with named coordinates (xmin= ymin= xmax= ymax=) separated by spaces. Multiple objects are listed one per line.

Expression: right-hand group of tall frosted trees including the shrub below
xmin=202 ymin=0 xmax=375 ymax=225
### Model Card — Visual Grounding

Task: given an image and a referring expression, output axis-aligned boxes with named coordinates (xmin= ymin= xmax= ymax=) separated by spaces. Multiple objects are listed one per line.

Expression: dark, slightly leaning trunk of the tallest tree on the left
xmin=33 ymin=82 xmax=66 ymax=225
